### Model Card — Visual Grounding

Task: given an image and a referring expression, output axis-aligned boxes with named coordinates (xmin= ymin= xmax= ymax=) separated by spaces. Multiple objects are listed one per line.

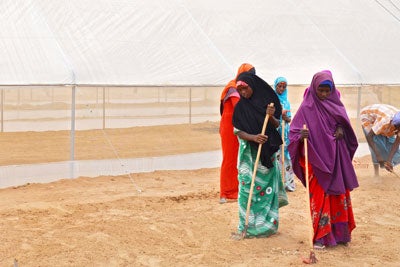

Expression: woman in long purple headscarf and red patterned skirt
xmin=288 ymin=71 xmax=359 ymax=249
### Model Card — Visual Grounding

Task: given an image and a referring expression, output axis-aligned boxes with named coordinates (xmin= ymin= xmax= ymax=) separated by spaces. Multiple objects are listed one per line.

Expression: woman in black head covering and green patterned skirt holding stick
xmin=232 ymin=72 xmax=288 ymax=238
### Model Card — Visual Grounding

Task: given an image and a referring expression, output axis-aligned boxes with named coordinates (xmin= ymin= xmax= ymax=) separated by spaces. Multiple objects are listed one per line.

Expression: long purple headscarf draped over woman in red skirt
xmin=288 ymin=71 xmax=358 ymax=195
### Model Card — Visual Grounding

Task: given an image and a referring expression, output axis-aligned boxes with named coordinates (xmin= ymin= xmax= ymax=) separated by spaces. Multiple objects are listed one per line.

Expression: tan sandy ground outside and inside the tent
xmin=0 ymin=123 xmax=400 ymax=266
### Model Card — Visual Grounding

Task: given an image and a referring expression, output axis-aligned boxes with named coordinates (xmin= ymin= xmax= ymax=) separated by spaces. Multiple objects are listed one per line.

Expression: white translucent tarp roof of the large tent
xmin=0 ymin=0 xmax=400 ymax=85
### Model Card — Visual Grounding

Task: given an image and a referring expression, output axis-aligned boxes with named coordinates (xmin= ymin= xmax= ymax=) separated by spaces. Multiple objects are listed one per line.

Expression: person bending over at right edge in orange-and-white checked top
xmin=360 ymin=104 xmax=400 ymax=176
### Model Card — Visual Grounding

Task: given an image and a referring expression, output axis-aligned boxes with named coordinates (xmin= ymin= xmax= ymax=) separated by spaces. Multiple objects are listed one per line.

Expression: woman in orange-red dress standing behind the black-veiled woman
xmin=219 ymin=63 xmax=255 ymax=204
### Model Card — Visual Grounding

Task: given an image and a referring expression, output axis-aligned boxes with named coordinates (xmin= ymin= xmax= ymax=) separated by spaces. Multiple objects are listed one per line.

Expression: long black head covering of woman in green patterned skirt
xmin=232 ymin=72 xmax=282 ymax=168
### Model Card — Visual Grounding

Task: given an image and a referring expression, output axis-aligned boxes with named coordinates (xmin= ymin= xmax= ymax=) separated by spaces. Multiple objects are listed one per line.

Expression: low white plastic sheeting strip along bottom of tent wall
xmin=0 ymin=146 xmax=369 ymax=189
